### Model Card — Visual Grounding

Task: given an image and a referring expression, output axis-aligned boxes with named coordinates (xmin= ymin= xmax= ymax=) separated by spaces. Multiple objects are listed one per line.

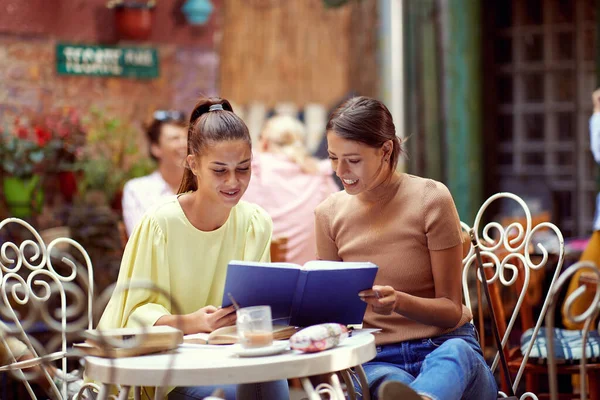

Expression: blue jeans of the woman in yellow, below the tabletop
xmin=169 ymin=380 xmax=290 ymax=400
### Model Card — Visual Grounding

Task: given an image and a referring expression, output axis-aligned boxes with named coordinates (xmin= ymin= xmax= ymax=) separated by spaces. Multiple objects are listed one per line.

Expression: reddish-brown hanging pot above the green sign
xmin=107 ymin=0 xmax=155 ymax=40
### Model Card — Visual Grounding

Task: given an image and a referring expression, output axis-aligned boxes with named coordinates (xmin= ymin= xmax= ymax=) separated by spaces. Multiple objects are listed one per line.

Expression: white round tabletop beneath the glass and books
xmin=85 ymin=333 xmax=377 ymax=386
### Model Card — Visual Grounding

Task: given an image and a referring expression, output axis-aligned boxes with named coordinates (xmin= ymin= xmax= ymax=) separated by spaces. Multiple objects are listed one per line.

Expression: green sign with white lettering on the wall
xmin=56 ymin=44 xmax=159 ymax=79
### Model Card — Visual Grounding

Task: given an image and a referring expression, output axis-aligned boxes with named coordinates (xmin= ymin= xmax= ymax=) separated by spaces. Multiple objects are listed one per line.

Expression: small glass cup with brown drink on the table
xmin=236 ymin=306 xmax=273 ymax=349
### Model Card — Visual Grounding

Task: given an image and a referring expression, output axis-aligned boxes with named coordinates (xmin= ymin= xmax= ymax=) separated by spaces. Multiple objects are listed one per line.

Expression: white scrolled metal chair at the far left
xmin=0 ymin=218 xmax=94 ymax=399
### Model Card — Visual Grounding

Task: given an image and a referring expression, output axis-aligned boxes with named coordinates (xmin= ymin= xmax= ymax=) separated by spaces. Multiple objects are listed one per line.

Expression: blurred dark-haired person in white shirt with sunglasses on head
xmin=122 ymin=110 xmax=188 ymax=236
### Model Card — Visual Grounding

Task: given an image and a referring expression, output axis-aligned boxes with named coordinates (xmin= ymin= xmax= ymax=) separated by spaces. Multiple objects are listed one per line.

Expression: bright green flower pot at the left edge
xmin=2 ymin=175 xmax=44 ymax=218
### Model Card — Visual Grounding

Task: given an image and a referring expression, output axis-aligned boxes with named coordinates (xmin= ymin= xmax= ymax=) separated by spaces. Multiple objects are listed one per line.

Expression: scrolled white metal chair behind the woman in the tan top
xmin=461 ymin=192 xmax=565 ymax=398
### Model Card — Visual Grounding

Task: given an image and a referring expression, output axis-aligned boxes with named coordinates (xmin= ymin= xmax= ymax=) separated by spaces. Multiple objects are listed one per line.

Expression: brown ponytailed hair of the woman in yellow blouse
xmin=177 ymin=97 xmax=252 ymax=193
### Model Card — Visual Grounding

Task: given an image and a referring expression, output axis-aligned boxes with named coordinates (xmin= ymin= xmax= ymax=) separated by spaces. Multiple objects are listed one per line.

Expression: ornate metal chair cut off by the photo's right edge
xmin=546 ymin=261 xmax=600 ymax=400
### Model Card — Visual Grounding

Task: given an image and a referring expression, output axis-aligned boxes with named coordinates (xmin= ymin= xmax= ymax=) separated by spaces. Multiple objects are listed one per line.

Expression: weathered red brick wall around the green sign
xmin=0 ymin=0 xmax=221 ymax=124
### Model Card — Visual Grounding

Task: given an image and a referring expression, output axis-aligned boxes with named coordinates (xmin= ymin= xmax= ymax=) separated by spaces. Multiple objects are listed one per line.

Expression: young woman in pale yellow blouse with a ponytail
xmin=98 ymin=98 xmax=289 ymax=399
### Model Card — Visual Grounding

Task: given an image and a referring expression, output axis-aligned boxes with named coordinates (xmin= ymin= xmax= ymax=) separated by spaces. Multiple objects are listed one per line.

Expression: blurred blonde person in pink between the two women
xmin=244 ymin=115 xmax=339 ymax=264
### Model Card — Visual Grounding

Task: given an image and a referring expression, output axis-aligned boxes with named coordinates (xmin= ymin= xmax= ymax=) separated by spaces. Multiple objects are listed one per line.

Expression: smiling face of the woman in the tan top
xmin=327 ymin=131 xmax=392 ymax=195
